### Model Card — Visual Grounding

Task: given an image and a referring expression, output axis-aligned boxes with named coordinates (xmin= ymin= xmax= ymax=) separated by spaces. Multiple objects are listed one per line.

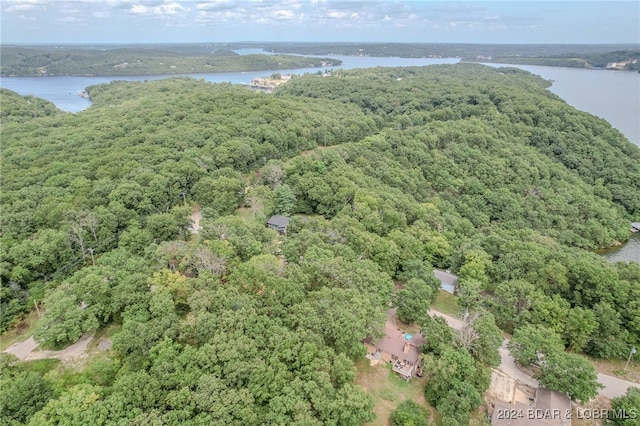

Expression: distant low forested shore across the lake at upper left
xmin=0 ymin=46 xmax=342 ymax=77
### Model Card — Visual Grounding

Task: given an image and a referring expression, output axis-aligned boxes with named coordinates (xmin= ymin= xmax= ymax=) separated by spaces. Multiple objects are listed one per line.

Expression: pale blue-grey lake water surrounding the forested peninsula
xmin=0 ymin=54 xmax=640 ymax=263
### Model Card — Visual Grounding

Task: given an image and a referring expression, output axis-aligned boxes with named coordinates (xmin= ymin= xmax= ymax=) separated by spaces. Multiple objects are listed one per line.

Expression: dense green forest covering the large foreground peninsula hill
xmin=0 ymin=64 xmax=640 ymax=425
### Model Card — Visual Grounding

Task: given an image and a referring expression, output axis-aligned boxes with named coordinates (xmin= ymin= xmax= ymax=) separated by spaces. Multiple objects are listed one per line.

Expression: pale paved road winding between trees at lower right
xmin=429 ymin=309 xmax=640 ymax=398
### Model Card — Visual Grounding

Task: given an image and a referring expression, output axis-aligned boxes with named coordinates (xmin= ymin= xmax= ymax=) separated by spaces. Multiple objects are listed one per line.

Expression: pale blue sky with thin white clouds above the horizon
xmin=0 ymin=0 xmax=640 ymax=43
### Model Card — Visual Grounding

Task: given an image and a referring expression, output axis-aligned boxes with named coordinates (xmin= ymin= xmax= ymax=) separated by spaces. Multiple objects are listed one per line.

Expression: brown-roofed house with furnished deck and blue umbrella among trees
xmin=364 ymin=309 xmax=426 ymax=380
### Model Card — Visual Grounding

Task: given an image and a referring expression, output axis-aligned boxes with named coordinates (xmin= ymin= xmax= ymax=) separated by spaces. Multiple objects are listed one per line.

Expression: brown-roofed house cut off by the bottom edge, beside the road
xmin=491 ymin=388 xmax=571 ymax=426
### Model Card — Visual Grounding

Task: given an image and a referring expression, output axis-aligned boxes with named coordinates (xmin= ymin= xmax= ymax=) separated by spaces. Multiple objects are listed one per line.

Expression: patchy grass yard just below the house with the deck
xmin=356 ymin=358 xmax=434 ymax=426
